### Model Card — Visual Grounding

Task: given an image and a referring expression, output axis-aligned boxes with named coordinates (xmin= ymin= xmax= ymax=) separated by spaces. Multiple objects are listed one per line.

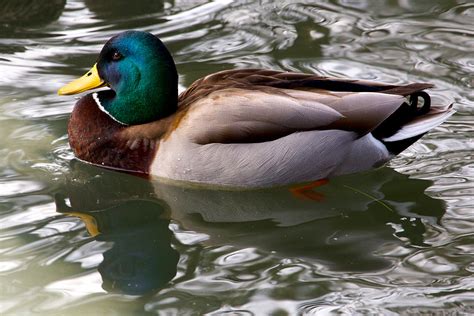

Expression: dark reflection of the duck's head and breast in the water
xmin=55 ymin=165 xmax=179 ymax=295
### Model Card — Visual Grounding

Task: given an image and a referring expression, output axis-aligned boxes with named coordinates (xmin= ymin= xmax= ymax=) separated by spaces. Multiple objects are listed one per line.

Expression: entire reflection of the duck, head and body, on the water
xmin=57 ymin=163 xmax=444 ymax=294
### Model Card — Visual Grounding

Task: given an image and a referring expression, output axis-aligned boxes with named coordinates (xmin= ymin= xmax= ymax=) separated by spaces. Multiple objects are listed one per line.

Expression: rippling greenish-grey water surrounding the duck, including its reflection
xmin=0 ymin=0 xmax=474 ymax=315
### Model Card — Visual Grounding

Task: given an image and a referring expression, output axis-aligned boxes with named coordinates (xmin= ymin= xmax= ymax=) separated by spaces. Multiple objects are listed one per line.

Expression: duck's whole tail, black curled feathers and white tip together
xmin=372 ymin=91 xmax=456 ymax=155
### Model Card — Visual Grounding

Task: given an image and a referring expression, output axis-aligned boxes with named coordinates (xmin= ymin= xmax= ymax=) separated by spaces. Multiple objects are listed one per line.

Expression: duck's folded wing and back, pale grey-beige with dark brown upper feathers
xmin=179 ymin=70 xmax=429 ymax=144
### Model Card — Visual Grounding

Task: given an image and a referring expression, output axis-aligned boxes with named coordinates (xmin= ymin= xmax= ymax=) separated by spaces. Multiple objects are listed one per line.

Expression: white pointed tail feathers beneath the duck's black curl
xmin=382 ymin=109 xmax=456 ymax=142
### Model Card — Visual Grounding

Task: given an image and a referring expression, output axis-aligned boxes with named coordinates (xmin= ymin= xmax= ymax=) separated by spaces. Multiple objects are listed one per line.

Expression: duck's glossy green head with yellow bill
xmin=58 ymin=31 xmax=178 ymax=125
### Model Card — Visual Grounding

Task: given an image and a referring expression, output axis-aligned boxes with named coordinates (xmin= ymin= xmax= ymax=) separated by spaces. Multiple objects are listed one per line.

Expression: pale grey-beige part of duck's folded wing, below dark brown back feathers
xmin=179 ymin=88 xmax=404 ymax=144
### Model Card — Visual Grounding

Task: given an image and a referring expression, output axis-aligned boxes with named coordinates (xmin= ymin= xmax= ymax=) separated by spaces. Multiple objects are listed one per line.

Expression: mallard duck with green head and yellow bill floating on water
xmin=58 ymin=31 xmax=454 ymax=188
